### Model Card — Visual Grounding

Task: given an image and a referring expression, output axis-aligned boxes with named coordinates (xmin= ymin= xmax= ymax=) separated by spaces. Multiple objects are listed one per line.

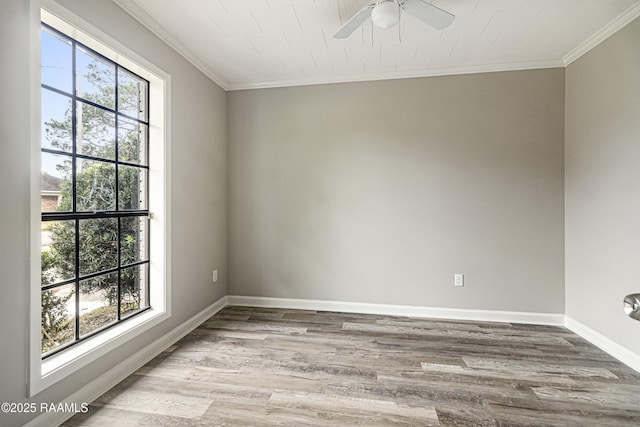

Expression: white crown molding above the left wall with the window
xmin=113 ymin=0 xmax=229 ymax=91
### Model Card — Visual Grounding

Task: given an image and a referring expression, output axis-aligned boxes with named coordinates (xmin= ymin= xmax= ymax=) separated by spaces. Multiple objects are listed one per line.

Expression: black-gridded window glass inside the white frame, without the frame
xmin=40 ymin=24 xmax=150 ymax=358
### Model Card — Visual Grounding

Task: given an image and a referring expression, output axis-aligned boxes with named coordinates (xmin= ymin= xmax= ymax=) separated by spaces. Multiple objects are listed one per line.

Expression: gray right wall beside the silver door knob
xmin=565 ymin=19 xmax=640 ymax=354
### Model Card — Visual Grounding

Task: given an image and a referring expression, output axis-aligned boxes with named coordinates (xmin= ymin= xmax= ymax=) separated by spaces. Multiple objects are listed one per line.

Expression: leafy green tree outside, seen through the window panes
xmin=42 ymin=60 xmax=146 ymax=352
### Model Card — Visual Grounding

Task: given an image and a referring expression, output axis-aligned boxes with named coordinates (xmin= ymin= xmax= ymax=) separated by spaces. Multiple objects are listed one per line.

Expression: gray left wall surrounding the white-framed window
xmin=0 ymin=0 xmax=226 ymax=427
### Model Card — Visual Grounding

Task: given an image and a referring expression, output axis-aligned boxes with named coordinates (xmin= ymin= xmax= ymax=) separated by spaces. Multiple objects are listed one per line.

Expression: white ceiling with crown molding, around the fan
xmin=114 ymin=0 xmax=640 ymax=90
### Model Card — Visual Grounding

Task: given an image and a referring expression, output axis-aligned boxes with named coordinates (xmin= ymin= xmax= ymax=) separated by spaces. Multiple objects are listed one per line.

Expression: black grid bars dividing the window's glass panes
xmin=40 ymin=22 xmax=150 ymax=359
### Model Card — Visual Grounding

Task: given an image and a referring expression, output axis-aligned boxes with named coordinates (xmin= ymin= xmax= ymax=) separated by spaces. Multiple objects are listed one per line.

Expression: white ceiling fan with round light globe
xmin=333 ymin=0 xmax=455 ymax=39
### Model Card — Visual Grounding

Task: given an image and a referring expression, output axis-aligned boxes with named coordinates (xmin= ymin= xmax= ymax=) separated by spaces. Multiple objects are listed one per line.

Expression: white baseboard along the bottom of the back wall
xmin=227 ymin=295 xmax=564 ymax=326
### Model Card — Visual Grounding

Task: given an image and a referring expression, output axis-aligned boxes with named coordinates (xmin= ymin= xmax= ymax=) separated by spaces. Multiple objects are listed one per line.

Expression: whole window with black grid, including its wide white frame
xmin=29 ymin=4 xmax=171 ymax=396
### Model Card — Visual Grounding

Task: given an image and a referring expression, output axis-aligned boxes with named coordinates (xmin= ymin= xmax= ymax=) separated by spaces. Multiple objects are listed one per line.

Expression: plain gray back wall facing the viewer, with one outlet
xmin=227 ymin=69 xmax=564 ymax=313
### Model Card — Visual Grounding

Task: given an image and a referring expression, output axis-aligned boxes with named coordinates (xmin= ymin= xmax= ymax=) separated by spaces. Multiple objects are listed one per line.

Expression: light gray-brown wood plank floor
xmin=65 ymin=307 xmax=640 ymax=427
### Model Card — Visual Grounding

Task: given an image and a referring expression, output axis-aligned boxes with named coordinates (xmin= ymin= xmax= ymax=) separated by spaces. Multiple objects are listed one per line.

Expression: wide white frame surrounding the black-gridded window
xmin=27 ymin=0 xmax=171 ymax=397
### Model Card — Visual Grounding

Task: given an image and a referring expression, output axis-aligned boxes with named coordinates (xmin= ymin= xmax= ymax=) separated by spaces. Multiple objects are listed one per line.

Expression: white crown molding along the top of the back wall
xmin=227 ymin=59 xmax=564 ymax=91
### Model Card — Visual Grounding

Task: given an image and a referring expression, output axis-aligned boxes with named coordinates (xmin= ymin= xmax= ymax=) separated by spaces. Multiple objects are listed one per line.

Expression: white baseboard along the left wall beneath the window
xmin=25 ymin=296 xmax=227 ymax=427
